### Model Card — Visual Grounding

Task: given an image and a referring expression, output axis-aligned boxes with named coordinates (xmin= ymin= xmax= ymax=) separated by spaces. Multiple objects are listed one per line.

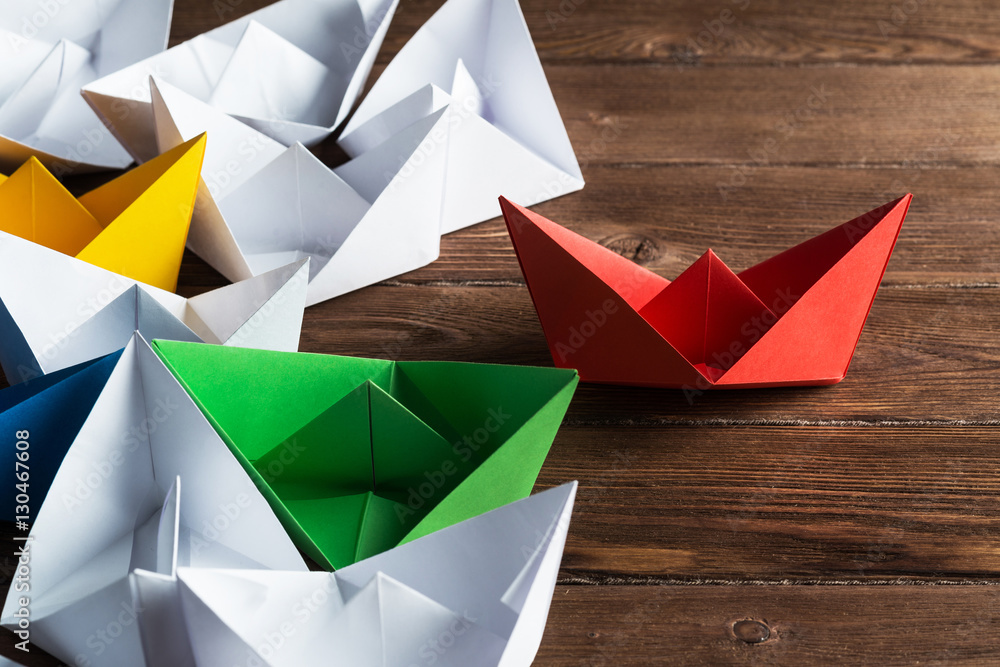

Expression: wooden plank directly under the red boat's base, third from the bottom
xmin=264 ymin=286 xmax=1000 ymax=426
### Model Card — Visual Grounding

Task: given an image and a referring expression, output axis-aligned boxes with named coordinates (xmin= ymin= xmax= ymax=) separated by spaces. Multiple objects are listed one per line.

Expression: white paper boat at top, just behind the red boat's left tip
xmin=338 ymin=0 xmax=584 ymax=234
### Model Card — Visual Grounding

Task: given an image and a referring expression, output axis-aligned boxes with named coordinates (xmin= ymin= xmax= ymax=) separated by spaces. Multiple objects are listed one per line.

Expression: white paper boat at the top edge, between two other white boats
xmin=83 ymin=0 xmax=399 ymax=162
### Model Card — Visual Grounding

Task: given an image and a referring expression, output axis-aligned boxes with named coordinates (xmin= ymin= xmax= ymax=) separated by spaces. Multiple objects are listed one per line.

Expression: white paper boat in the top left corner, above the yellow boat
xmin=0 ymin=0 xmax=173 ymax=176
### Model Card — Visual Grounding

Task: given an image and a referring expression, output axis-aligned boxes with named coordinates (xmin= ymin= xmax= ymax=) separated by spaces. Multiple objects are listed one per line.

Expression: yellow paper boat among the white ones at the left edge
xmin=0 ymin=134 xmax=205 ymax=292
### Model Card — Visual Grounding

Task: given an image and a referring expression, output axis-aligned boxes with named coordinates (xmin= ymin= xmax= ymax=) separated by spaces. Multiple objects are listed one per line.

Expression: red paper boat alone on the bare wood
xmin=500 ymin=195 xmax=912 ymax=389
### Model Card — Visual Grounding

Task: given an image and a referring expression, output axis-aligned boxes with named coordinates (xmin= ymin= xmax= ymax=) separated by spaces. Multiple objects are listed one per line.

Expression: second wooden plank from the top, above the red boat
xmin=540 ymin=65 xmax=1000 ymax=166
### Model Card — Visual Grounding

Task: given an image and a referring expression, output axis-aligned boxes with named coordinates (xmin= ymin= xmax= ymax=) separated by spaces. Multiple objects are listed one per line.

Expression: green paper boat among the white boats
xmin=153 ymin=340 xmax=578 ymax=569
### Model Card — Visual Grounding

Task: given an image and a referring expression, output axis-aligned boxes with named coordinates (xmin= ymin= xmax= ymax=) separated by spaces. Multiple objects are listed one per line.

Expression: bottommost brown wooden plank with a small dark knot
xmin=535 ymin=586 xmax=1000 ymax=667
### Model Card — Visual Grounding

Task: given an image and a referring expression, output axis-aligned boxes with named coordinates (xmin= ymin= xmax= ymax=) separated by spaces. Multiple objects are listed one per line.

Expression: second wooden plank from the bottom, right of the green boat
xmin=539 ymin=424 xmax=1000 ymax=584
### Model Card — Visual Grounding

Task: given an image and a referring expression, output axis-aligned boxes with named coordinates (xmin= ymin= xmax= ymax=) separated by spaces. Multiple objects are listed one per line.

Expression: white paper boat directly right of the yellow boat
xmin=151 ymin=79 xmax=451 ymax=305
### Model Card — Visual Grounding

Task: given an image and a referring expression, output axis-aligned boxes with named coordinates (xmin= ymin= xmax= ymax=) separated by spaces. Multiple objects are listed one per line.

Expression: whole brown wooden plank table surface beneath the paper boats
xmin=0 ymin=0 xmax=1000 ymax=666
